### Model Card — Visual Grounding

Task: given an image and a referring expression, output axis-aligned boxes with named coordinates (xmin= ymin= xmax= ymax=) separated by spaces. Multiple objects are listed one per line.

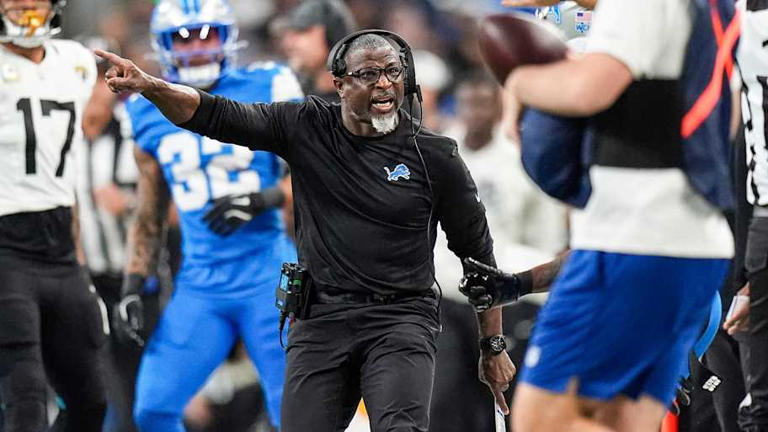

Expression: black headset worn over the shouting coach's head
xmin=326 ymin=29 xmax=421 ymax=102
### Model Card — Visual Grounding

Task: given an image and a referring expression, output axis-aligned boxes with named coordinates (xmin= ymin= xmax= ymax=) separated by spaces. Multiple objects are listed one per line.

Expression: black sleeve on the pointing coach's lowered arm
xmin=436 ymin=147 xmax=496 ymax=273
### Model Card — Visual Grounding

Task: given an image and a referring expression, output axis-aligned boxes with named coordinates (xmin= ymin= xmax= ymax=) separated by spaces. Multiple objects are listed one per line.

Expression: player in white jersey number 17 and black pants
xmin=0 ymin=0 xmax=108 ymax=432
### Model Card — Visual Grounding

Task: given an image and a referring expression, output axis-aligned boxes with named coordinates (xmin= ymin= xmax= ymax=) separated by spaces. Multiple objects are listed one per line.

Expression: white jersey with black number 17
xmin=0 ymin=40 xmax=96 ymax=216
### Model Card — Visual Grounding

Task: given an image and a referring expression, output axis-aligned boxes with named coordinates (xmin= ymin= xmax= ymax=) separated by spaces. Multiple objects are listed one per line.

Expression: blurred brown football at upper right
xmin=480 ymin=13 xmax=568 ymax=85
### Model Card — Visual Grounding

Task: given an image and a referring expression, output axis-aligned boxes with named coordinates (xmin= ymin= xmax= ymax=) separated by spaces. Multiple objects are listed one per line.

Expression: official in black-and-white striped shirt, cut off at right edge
xmin=726 ymin=0 xmax=768 ymax=431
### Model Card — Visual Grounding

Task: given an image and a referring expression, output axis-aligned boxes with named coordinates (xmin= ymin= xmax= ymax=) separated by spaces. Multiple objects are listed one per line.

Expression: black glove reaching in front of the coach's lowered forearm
xmin=459 ymin=258 xmax=531 ymax=312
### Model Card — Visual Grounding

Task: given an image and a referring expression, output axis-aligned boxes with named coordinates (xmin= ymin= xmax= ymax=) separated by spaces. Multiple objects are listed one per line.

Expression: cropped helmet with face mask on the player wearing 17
xmin=0 ymin=0 xmax=67 ymax=48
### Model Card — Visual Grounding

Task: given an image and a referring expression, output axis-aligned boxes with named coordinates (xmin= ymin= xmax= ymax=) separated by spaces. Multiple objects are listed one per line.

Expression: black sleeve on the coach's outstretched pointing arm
xmin=177 ymin=90 xmax=300 ymax=158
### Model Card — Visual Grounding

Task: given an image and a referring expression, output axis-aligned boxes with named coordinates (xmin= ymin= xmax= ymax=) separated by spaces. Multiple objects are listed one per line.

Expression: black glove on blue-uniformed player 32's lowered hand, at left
xmin=112 ymin=273 xmax=145 ymax=347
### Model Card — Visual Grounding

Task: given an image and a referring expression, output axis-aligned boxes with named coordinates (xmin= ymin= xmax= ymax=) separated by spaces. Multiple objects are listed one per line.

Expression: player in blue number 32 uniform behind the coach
xmin=115 ymin=0 xmax=302 ymax=432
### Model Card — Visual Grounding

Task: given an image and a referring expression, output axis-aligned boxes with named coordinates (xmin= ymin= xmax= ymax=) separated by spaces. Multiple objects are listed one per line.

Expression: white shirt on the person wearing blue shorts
xmin=571 ymin=0 xmax=733 ymax=258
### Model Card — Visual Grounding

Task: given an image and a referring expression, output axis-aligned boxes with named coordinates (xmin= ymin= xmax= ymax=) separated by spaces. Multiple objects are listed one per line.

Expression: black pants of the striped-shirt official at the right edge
xmin=744 ymin=214 xmax=768 ymax=432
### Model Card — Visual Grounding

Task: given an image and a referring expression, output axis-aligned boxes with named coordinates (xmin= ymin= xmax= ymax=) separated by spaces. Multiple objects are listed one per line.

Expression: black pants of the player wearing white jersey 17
xmin=0 ymin=258 xmax=106 ymax=432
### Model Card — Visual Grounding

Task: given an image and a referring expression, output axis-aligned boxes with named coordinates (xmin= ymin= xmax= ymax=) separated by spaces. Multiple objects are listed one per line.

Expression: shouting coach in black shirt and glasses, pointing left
xmin=97 ymin=30 xmax=515 ymax=432
